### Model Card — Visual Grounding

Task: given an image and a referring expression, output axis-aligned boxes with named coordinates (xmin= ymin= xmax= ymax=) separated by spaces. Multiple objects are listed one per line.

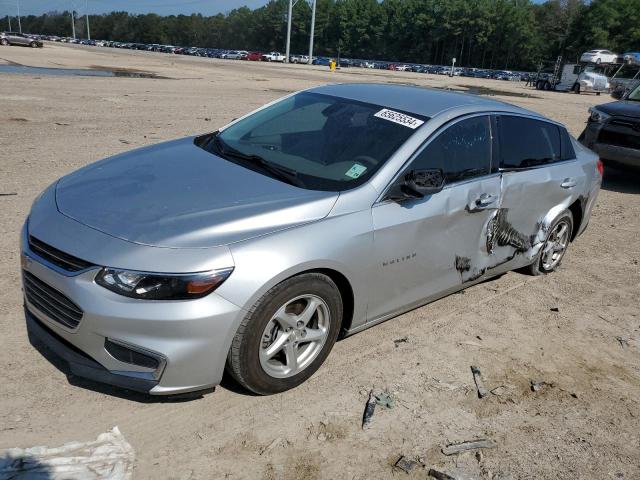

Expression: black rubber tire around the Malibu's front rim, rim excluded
xmin=227 ymin=273 xmax=342 ymax=395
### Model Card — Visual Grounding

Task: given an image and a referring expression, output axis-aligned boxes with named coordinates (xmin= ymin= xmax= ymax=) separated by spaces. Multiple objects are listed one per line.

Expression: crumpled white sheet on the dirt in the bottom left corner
xmin=0 ymin=427 xmax=135 ymax=480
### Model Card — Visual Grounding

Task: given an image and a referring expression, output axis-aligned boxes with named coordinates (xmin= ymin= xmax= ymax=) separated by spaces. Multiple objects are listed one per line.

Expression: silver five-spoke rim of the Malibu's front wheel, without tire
xmin=259 ymin=294 xmax=331 ymax=378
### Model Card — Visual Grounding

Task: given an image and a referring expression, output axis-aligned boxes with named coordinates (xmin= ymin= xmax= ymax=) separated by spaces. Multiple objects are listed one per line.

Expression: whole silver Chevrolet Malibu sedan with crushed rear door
xmin=21 ymin=84 xmax=602 ymax=395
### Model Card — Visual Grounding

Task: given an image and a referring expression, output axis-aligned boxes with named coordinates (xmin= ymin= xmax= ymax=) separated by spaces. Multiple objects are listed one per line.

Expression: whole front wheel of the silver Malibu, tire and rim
xmin=227 ymin=273 xmax=342 ymax=395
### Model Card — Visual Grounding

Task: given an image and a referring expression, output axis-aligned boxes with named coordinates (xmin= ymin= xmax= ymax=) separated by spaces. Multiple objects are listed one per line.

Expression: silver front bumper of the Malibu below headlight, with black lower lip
xmin=22 ymin=226 xmax=244 ymax=395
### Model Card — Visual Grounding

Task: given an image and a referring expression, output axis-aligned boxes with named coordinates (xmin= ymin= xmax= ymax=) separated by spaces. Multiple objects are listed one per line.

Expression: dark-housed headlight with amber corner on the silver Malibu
xmin=95 ymin=267 xmax=233 ymax=300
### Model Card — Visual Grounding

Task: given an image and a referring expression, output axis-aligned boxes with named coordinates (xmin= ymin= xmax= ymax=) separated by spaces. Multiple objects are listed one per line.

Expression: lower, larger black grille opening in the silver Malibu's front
xmin=22 ymin=270 xmax=83 ymax=328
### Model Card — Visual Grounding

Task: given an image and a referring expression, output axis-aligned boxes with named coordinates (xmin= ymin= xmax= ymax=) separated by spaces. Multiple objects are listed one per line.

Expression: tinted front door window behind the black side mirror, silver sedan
xmin=411 ymin=116 xmax=492 ymax=184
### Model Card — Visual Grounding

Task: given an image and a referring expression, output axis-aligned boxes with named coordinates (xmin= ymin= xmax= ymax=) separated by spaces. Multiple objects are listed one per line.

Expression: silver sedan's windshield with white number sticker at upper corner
xmin=197 ymin=92 xmax=427 ymax=191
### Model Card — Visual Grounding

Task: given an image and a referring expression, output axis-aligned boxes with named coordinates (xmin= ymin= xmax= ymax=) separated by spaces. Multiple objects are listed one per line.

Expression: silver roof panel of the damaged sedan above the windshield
xmin=308 ymin=83 xmax=540 ymax=118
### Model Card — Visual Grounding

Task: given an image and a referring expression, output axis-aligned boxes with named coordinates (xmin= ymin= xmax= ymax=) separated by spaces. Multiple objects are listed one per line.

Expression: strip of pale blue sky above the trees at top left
xmin=0 ymin=0 xmax=268 ymax=17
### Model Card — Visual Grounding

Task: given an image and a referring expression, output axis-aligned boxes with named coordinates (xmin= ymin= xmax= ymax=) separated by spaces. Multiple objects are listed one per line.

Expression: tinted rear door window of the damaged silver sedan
xmin=497 ymin=115 xmax=562 ymax=168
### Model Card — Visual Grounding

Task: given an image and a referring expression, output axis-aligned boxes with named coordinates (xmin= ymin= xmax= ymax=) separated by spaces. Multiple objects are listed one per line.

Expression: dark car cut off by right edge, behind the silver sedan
xmin=578 ymin=85 xmax=640 ymax=170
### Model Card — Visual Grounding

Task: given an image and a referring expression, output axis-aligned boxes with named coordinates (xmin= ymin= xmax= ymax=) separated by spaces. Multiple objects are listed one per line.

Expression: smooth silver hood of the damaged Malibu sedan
xmin=56 ymin=138 xmax=338 ymax=248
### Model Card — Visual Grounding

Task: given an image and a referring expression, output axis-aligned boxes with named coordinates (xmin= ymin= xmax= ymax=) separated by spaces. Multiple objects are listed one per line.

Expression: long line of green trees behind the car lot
xmin=3 ymin=0 xmax=640 ymax=70
